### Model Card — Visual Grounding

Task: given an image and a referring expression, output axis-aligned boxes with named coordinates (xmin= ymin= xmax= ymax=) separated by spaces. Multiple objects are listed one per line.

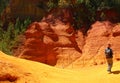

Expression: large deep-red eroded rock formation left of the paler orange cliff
xmin=19 ymin=17 xmax=82 ymax=65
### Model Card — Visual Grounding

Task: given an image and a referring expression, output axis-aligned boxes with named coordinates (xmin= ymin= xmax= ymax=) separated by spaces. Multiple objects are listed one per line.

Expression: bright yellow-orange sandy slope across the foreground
xmin=0 ymin=52 xmax=120 ymax=83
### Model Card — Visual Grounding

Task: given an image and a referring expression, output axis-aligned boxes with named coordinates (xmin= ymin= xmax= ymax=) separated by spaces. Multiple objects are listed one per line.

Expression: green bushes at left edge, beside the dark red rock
xmin=0 ymin=19 xmax=31 ymax=55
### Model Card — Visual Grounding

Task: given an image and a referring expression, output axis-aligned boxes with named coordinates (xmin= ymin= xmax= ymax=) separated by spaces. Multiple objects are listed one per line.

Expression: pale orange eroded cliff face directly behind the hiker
xmin=69 ymin=21 xmax=120 ymax=67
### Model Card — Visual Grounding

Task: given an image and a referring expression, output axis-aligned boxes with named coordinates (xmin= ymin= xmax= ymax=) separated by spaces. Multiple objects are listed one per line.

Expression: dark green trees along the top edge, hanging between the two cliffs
xmin=37 ymin=0 xmax=120 ymax=29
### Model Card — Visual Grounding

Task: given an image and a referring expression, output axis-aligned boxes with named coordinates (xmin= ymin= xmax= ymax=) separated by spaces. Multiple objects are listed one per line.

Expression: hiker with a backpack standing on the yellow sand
xmin=105 ymin=44 xmax=113 ymax=73
